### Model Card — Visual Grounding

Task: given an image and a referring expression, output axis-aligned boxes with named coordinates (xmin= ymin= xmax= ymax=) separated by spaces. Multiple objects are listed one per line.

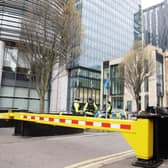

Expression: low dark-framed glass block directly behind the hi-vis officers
xmin=69 ymin=67 xmax=100 ymax=107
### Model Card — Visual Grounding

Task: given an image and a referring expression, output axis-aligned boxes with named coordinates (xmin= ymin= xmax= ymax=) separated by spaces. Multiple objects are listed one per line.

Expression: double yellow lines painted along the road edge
xmin=65 ymin=150 xmax=134 ymax=168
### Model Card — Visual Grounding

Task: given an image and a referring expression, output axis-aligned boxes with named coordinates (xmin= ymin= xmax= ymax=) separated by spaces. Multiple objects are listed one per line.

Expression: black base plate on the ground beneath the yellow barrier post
xmin=132 ymin=159 xmax=163 ymax=168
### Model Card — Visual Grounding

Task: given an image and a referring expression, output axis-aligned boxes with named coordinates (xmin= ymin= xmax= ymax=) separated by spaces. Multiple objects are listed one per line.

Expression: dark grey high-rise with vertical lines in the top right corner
xmin=143 ymin=0 xmax=168 ymax=50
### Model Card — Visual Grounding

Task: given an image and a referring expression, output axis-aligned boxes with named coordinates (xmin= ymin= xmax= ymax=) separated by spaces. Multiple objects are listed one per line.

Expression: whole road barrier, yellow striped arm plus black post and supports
xmin=0 ymin=110 xmax=168 ymax=168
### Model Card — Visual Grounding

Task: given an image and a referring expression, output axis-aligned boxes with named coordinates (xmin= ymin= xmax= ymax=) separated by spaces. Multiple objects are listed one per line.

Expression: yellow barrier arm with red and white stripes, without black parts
xmin=0 ymin=112 xmax=153 ymax=160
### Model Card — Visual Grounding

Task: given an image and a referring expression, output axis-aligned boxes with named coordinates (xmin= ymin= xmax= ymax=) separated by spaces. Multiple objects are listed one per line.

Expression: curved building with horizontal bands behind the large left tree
xmin=0 ymin=0 xmax=63 ymax=112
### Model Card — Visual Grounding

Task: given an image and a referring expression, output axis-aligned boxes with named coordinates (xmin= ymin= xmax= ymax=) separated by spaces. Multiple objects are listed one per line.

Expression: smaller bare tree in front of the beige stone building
xmin=119 ymin=42 xmax=154 ymax=112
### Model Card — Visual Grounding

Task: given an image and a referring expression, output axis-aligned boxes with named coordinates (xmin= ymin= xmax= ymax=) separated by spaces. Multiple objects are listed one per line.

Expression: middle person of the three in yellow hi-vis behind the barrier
xmin=83 ymin=98 xmax=98 ymax=117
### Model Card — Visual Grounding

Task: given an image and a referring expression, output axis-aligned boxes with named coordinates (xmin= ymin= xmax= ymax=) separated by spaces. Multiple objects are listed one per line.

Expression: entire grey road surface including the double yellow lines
xmin=0 ymin=128 xmax=168 ymax=168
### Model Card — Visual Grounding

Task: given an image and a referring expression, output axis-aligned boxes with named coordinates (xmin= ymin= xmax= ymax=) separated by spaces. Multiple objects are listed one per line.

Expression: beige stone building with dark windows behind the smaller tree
xmin=101 ymin=47 xmax=168 ymax=112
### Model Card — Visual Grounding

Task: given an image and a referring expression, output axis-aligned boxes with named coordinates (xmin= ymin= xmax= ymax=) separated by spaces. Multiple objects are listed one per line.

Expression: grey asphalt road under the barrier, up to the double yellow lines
xmin=0 ymin=128 xmax=130 ymax=168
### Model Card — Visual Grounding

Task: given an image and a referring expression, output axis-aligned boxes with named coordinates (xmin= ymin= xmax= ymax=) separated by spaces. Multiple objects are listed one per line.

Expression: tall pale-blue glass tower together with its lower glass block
xmin=54 ymin=0 xmax=142 ymax=110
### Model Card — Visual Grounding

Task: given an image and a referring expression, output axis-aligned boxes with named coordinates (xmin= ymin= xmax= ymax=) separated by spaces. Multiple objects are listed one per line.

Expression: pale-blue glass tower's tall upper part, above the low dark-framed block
xmin=77 ymin=0 xmax=142 ymax=68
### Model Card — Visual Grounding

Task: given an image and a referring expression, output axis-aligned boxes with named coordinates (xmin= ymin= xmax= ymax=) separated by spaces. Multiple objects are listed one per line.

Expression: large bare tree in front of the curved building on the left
xmin=18 ymin=0 xmax=81 ymax=113
